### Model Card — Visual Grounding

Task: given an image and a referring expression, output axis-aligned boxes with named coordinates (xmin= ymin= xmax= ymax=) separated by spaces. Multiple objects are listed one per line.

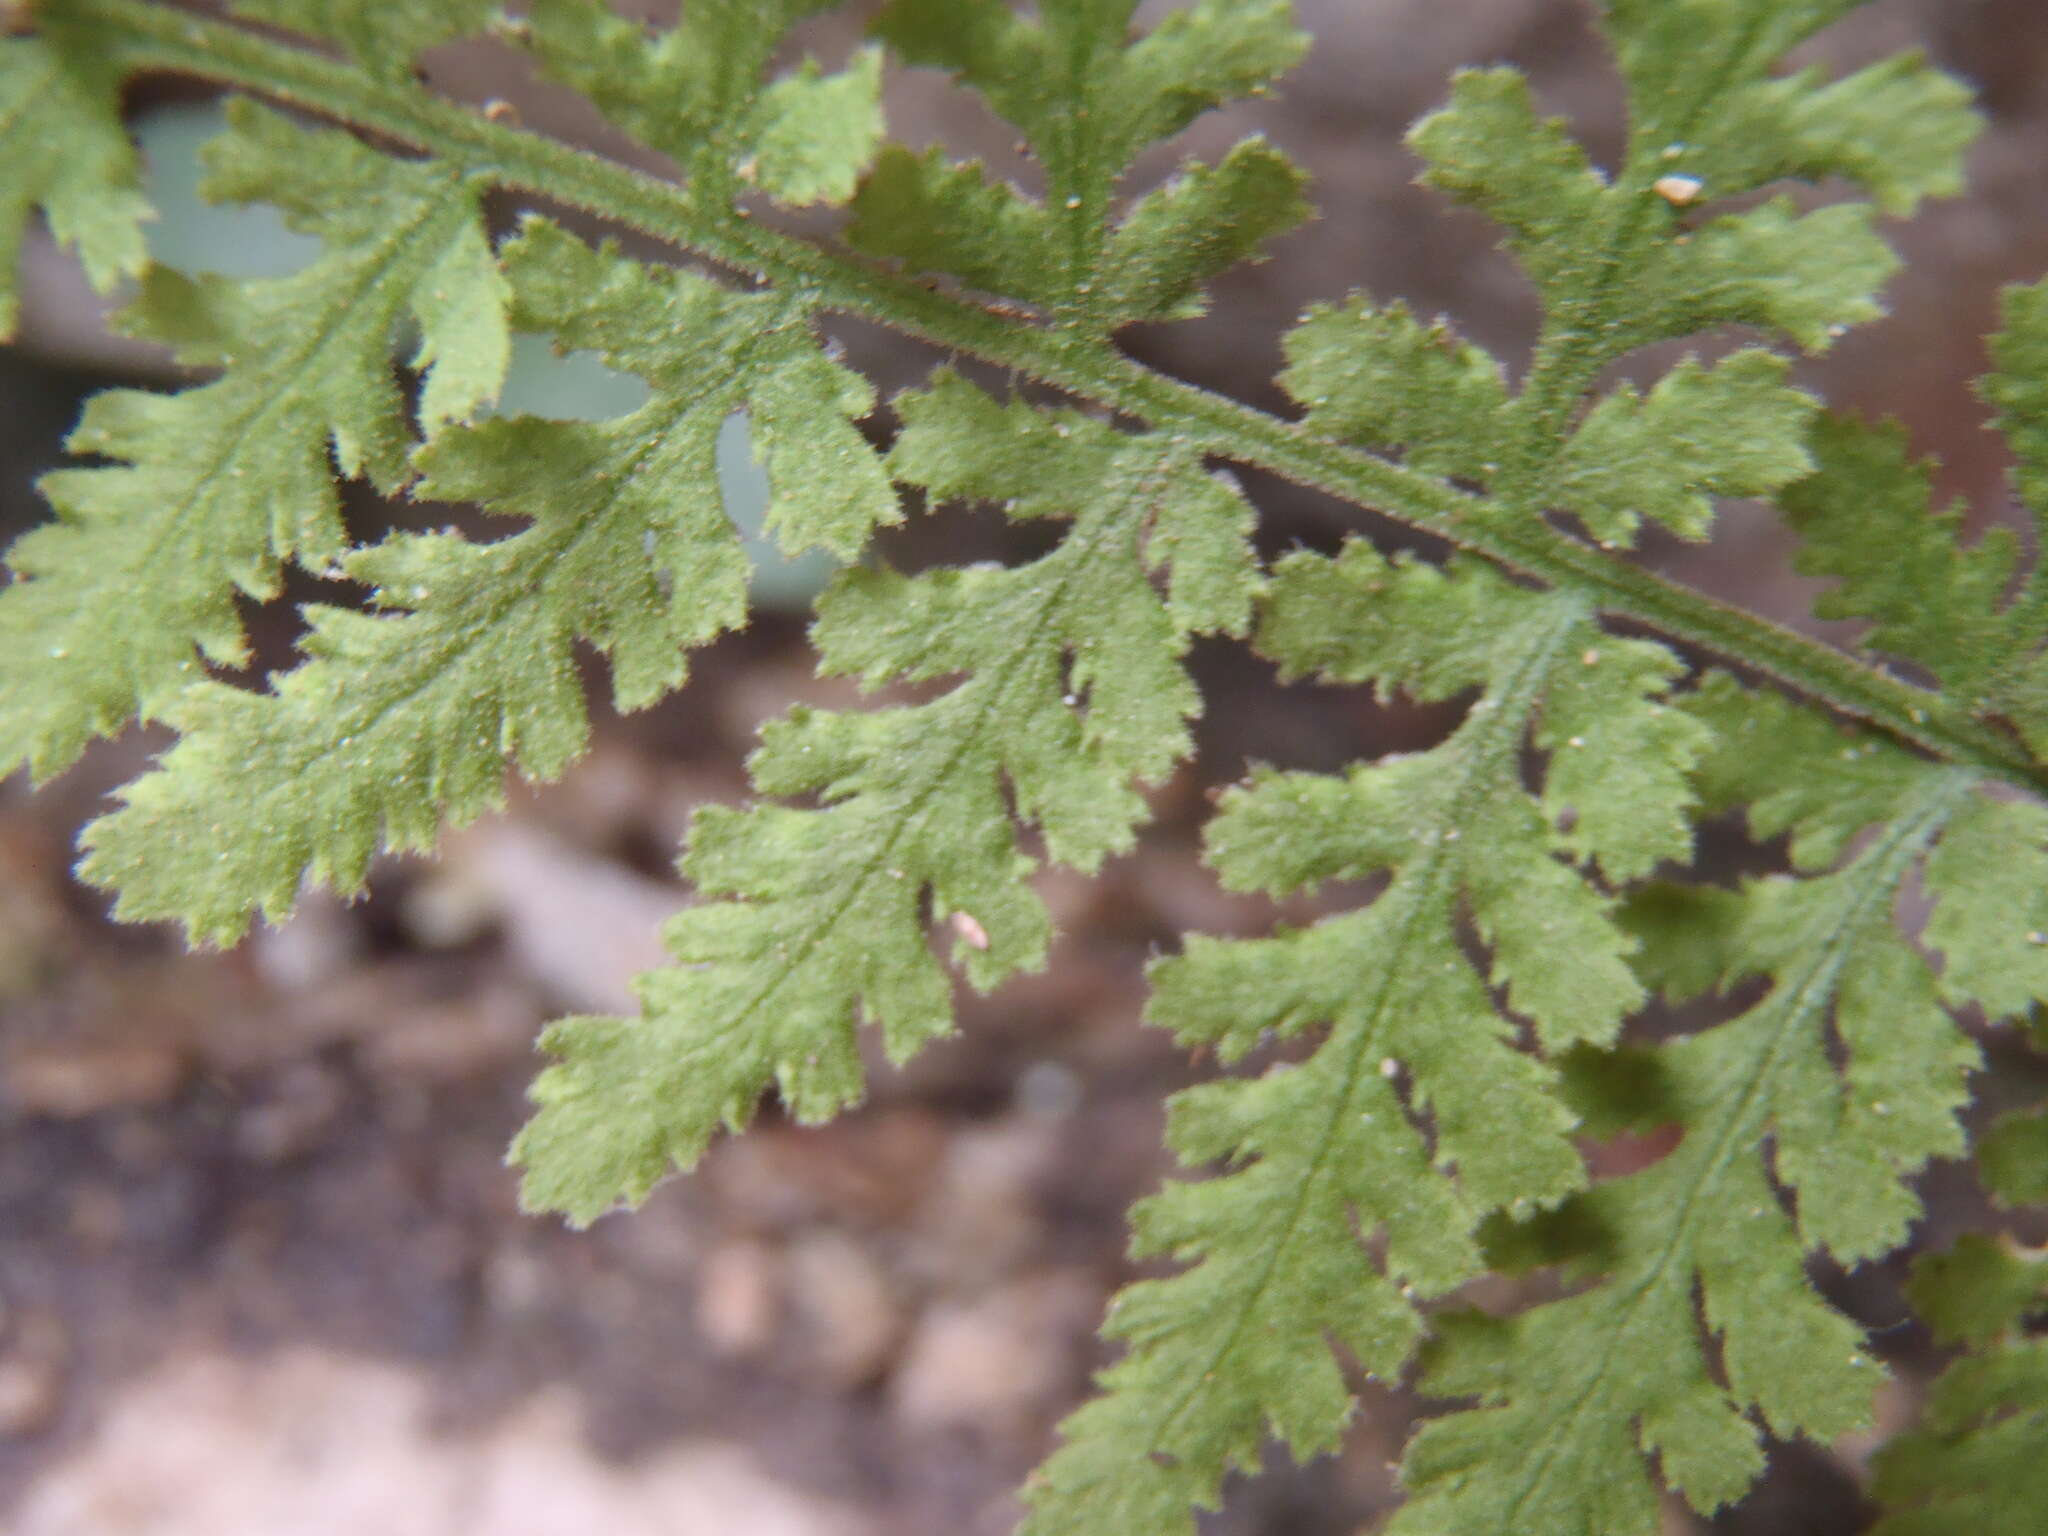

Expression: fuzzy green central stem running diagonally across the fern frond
xmin=63 ymin=0 xmax=2048 ymax=795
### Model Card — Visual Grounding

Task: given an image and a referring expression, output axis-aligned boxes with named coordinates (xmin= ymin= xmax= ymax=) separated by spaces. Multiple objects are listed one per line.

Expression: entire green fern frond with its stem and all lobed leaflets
xmin=0 ymin=0 xmax=2048 ymax=1536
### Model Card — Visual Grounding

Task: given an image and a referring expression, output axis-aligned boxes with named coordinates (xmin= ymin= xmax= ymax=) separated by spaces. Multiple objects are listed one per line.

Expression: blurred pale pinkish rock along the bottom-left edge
xmin=8 ymin=1348 xmax=879 ymax=1536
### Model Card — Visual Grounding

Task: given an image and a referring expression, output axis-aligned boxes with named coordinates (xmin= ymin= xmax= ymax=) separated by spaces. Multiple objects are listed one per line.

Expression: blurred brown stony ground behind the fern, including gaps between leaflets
xmin=0 ymin=0 xmax=2048 ymax=1536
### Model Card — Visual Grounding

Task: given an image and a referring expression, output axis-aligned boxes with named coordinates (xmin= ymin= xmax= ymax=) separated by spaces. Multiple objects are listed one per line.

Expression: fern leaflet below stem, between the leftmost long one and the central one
xmin=82 ymin=221 xmax=897 ymax=942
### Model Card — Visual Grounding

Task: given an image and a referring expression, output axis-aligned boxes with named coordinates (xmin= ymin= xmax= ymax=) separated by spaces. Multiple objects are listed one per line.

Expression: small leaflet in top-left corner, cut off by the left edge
xmin=0 ymin=20 xmax=152 ymax=340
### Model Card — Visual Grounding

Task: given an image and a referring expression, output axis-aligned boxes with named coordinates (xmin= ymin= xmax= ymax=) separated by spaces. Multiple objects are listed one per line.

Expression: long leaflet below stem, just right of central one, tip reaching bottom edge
xmin=1026 ymin=543 xmax=1706 ymax=1536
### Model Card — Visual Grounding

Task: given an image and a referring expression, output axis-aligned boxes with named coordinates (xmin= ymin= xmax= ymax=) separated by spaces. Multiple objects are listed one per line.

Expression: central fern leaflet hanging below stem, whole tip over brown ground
xmin=514 ymin=375 xmax=1257 ymax=1221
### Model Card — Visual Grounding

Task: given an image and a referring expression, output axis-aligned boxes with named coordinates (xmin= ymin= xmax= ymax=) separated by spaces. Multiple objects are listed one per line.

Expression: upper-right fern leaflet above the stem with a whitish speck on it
xmin=1284 ymin=0 xmax=1976 ymax=547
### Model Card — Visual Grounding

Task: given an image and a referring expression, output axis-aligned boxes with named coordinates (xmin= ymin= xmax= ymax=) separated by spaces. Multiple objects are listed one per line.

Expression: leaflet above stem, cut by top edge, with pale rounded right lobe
xmin=514 ymin=0 xmax=883 ymax=205
